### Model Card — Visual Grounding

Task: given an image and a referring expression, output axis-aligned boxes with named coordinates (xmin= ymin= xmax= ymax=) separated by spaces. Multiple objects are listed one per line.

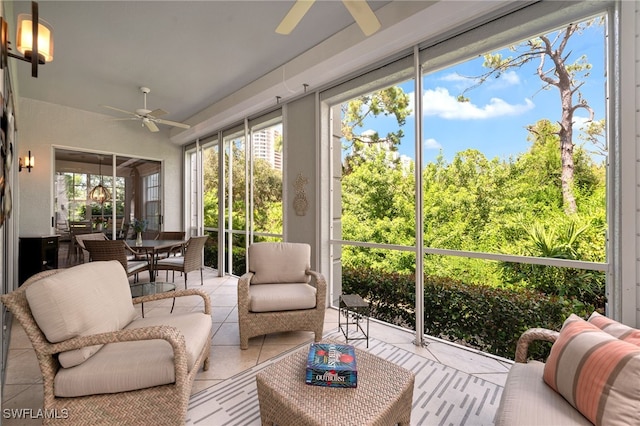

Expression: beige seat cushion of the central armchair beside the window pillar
xmin=249 ymin=283 xmax=316 ymax=312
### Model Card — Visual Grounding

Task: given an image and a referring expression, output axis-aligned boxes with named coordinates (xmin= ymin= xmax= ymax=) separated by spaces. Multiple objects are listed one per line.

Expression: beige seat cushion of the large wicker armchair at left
xmin=54 ymin=312 xmax=211 ymax=397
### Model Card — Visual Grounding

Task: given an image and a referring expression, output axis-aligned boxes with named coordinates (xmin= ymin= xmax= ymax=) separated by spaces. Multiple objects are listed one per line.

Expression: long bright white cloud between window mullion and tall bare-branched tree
xmin=423 ymin=87 xmax=534 ymax=120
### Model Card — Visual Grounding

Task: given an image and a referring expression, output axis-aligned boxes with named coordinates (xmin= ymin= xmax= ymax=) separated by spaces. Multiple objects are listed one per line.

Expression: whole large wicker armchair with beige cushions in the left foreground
xmin=1 ymin=261 xmax=212 ymax=425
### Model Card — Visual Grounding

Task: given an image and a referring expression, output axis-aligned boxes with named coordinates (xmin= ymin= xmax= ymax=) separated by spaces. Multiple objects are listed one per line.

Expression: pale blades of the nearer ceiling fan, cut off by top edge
xmin=276 ymin=0 xmax=380 ymax=36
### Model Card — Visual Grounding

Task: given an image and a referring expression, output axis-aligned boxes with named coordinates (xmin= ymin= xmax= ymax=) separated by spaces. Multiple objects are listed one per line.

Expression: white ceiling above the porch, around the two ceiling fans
xmin=4 ymin=0 xmax=524 ymax=142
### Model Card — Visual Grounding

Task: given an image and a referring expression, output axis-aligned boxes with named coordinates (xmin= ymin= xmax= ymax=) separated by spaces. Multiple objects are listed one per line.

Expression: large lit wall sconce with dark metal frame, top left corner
xmin=0 ymin=1 xmax=53 ymax=78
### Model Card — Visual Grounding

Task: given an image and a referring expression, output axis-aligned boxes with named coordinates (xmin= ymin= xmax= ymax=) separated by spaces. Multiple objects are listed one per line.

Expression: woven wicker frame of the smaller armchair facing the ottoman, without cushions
xmin=238 ymin=270 xmax=327 ymax=349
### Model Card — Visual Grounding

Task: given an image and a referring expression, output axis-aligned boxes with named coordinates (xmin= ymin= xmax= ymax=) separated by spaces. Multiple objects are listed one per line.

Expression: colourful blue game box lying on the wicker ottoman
xmin=305 ymin=343 xmax=358 ymax=388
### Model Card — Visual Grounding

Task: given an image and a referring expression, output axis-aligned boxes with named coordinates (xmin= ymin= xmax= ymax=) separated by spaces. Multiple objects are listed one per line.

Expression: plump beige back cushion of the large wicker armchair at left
xmin=26 ymin=260 xmax=136 ymax=368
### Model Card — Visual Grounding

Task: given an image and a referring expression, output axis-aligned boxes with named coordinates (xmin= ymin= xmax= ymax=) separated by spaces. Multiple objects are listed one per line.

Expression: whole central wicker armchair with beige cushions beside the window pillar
xmin=238 ymin=243 xmax=327 ymax=349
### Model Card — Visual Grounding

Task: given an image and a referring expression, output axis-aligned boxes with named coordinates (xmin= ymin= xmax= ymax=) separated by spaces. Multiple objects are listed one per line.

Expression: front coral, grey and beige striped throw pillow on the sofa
xmin=543 ymin=315 xmax=640 ymax=426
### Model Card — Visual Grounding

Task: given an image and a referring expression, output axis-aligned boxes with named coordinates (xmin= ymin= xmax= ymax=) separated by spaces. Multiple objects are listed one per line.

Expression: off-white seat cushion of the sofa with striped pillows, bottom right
xmin=495 ymin=361 xmax=592 ymax=426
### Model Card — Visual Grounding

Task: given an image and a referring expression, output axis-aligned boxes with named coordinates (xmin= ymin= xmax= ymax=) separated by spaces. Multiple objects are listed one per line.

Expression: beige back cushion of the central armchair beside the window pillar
xmin=249 ymin=243 xmax=311 ymax=285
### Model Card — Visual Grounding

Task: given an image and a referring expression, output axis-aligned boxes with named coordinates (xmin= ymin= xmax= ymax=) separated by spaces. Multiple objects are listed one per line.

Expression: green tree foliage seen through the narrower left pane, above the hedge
xmin=341 ymin=86 xmax=415 ymax=273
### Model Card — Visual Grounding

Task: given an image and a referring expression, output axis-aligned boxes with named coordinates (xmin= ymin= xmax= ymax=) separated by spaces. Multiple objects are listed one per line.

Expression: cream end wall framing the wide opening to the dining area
xmin=14 ymin=98 xmax=183 ymax=236
